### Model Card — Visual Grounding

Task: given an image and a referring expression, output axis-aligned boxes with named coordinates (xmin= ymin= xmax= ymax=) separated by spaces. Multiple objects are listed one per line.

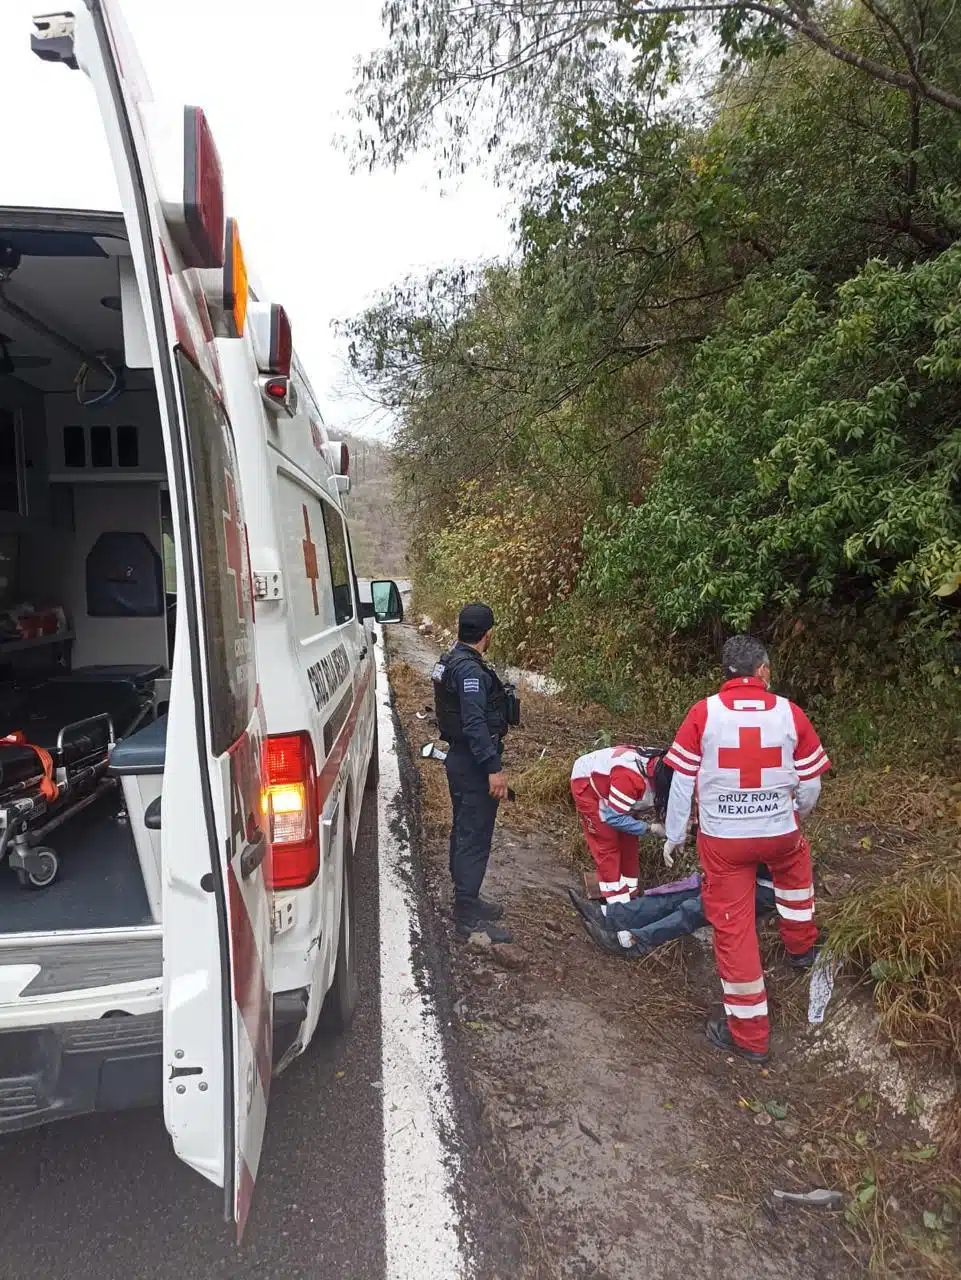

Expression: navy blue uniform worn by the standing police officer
xmin=434 ymin=616 xmax=512 ymax=922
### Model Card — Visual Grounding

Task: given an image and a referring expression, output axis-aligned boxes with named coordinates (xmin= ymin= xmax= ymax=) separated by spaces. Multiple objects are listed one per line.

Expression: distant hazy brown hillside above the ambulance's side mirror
xmin=344 ymin=435 xmax=407 ymax=577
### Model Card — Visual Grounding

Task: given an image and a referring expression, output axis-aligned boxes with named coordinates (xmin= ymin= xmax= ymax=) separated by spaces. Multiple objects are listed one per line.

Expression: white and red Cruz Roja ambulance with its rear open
xmin=0 ymin=0 xmax=403 ymax=1231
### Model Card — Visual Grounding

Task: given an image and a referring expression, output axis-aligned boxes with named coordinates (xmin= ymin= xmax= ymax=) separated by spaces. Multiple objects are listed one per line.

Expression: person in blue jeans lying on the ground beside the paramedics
xmin=568 ymin=867 xmax=774 ymax=960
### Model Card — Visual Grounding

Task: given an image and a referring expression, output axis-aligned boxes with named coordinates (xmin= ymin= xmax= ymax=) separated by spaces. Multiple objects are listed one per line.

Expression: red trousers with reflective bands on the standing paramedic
xmin=697 ymin=831 xmax=818 ymax=1052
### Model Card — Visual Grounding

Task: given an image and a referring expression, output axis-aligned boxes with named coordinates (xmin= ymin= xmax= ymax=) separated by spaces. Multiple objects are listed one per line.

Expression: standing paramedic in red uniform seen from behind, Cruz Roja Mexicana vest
xmin=664 ymin=635 xmax=830 ymax=1062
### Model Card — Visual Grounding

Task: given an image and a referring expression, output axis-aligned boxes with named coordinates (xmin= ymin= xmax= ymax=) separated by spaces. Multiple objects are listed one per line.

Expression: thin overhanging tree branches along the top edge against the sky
xmin=354 ymin=0 xmax=961 ymax=170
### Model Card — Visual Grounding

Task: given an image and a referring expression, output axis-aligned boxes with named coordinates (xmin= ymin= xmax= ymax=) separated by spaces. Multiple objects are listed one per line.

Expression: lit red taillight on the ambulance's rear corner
xmin=262 ymin=733 xmax=320 ymax=890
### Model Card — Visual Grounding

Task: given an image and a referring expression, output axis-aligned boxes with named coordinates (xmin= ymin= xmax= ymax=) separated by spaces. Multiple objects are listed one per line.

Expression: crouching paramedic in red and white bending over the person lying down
xmin=571 ymin=746 xmax=671 ymax=947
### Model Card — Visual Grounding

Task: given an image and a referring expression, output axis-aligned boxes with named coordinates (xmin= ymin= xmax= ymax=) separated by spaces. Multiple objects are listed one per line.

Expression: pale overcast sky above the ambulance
xmin=0 ymin=0 xmax=509 ymax=434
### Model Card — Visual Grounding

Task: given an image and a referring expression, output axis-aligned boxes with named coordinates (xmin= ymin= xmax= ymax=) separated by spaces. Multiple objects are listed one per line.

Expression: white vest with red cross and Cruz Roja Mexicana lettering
xmin=697 ymin=690 xmax=798 ymax=840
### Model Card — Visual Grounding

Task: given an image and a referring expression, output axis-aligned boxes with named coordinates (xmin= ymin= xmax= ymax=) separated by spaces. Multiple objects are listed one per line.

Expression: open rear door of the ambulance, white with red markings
xmin=33 ymin=0 xmax=273 ymax=1233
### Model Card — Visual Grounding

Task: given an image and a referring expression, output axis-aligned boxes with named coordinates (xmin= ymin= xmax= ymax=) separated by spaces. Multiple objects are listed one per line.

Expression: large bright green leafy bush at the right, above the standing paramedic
xmin=585 ymin=257 xmax=961 ymax=630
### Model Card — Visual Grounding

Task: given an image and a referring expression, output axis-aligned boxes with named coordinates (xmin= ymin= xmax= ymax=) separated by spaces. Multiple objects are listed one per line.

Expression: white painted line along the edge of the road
xmin=376 ymin=631 xmax=472 ymax=1280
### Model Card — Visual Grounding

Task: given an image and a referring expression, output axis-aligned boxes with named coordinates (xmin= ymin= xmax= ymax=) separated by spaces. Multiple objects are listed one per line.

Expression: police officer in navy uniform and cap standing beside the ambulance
xmin=434 ymin=604 xmax=518 ymax=942
